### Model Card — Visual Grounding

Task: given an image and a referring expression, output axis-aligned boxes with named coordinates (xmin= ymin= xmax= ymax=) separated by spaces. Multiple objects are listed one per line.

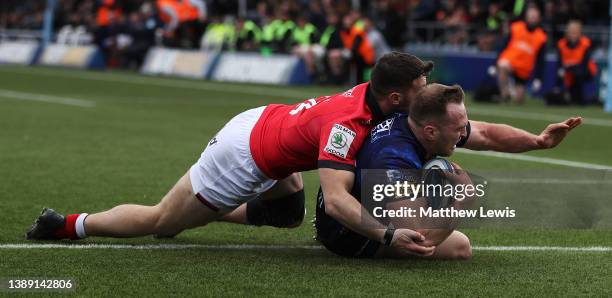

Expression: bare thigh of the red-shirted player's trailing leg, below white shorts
xmin=156 ymin=172 xmax=221 ymax=229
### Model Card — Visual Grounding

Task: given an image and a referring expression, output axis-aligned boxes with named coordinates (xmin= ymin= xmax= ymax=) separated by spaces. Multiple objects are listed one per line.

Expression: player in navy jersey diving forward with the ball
xmin=315 ymin=84 xmax=580 ymax=259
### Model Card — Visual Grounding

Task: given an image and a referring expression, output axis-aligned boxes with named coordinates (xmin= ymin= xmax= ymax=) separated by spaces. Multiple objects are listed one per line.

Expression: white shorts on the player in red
xmin=189 ymin=107 xmax=277 ymax=212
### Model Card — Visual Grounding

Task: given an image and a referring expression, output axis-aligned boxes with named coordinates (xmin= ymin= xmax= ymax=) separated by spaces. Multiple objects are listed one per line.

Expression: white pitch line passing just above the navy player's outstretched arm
xmin=468 ymin=107 xmax=612 ymax=127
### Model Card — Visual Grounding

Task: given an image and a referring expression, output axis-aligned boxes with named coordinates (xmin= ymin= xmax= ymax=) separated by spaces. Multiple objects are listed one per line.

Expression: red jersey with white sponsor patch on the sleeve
xmin=250 ymin=83 xmax=384 ymax=179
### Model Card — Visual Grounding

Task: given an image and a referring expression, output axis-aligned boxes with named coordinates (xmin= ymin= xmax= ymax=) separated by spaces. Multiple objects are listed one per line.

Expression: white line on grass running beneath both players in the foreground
xmin=0 ymin=243 xmax=612 ymax=252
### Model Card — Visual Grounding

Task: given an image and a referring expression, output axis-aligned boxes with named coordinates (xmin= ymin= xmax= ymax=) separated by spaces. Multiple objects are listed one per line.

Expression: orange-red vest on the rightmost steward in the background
xmin=557 ymin=36 xmax=597 ymax=87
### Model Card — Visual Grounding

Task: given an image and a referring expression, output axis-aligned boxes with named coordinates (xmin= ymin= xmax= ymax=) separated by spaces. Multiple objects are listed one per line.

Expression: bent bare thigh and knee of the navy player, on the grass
xmin=376 ymin=230 xmax=472 ymax=260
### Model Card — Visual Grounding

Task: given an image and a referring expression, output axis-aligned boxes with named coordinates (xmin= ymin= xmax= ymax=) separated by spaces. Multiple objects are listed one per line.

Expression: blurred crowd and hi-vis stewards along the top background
xmin=0 ymin=0 xmax=609 ymax=83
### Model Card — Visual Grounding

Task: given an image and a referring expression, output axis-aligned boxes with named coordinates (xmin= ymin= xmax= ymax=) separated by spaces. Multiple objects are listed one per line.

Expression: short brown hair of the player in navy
xmin=410 ymin=84 xmax=465 ymax=125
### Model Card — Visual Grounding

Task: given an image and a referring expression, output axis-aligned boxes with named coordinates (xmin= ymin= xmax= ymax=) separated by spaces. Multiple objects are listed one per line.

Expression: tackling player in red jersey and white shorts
xmin=26 ymin=52 xmax=580 ymax=255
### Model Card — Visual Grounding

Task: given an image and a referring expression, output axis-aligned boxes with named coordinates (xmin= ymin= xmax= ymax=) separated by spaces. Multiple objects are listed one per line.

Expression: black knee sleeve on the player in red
xmin=247 ymin=189 xmax=305 ymax=228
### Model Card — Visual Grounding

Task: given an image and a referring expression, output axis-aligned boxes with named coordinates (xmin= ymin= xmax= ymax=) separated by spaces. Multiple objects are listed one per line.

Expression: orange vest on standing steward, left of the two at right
xmin=499 ymin=21 xmax=546 ymax=80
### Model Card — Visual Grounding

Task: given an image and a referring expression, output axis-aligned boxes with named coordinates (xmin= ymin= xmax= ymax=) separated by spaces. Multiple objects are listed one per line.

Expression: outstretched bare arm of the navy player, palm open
xmin=464 ymin=117 xmax=582 ymax=153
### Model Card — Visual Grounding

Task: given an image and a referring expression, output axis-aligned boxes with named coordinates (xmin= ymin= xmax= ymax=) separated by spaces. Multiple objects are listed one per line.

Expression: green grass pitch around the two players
xmin=0 ymin=66 xmax=612 ymax=297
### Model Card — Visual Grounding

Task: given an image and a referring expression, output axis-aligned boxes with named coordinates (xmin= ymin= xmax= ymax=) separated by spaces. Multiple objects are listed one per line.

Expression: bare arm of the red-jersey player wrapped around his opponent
xmin=319 ymin=168 xmax=435 ymax=256
